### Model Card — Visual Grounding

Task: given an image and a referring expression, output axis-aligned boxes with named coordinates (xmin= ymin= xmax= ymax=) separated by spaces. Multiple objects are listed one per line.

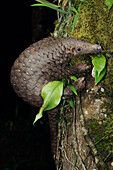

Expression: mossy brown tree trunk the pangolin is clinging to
xmin=53 ymin=0 xmax=113 ymax=170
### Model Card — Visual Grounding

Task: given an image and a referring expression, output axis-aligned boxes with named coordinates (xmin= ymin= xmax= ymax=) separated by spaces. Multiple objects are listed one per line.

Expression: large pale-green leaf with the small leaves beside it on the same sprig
xmin=33 ymin=76 xmax=78 ymax=124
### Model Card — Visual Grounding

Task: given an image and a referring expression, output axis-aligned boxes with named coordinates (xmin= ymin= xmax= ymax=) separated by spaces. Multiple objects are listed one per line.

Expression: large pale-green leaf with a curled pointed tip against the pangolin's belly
xmin=33 ymin=81 xmax=63 ymax=124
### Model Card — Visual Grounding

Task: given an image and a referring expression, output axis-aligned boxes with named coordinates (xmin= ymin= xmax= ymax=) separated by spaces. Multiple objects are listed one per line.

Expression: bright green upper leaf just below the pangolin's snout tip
xmin=92 ymin=54 xmax=106 ymax=77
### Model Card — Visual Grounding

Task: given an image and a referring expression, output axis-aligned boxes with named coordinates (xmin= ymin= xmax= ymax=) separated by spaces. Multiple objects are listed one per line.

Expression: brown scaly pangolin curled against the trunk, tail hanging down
xmin=10 ymin=37 xmax=101 ymax=159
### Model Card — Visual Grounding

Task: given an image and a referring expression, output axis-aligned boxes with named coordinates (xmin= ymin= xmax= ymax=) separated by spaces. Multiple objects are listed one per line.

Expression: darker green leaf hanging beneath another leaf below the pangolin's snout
xmin=95 ymin=68 xmax=106 ymax=85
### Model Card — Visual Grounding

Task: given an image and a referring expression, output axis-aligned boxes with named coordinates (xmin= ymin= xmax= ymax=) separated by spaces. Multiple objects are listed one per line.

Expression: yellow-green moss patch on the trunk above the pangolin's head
xmin=70 ymin=0 xmax=113 ymax=51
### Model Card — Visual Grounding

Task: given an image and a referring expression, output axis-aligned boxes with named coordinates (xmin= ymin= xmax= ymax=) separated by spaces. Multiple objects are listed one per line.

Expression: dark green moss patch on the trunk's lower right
xmin=89 ymin=115 xmax=113 ymax=160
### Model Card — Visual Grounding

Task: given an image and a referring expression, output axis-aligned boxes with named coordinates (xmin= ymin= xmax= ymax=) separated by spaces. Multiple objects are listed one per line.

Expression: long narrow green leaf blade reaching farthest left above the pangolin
xmin=31 ymin=4 xmax=68 ymax=14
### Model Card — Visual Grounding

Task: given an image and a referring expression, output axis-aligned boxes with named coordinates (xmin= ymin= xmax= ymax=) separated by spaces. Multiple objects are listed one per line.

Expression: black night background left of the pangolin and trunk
xmin=0 ymin=0 xmax=56 ymax=170
